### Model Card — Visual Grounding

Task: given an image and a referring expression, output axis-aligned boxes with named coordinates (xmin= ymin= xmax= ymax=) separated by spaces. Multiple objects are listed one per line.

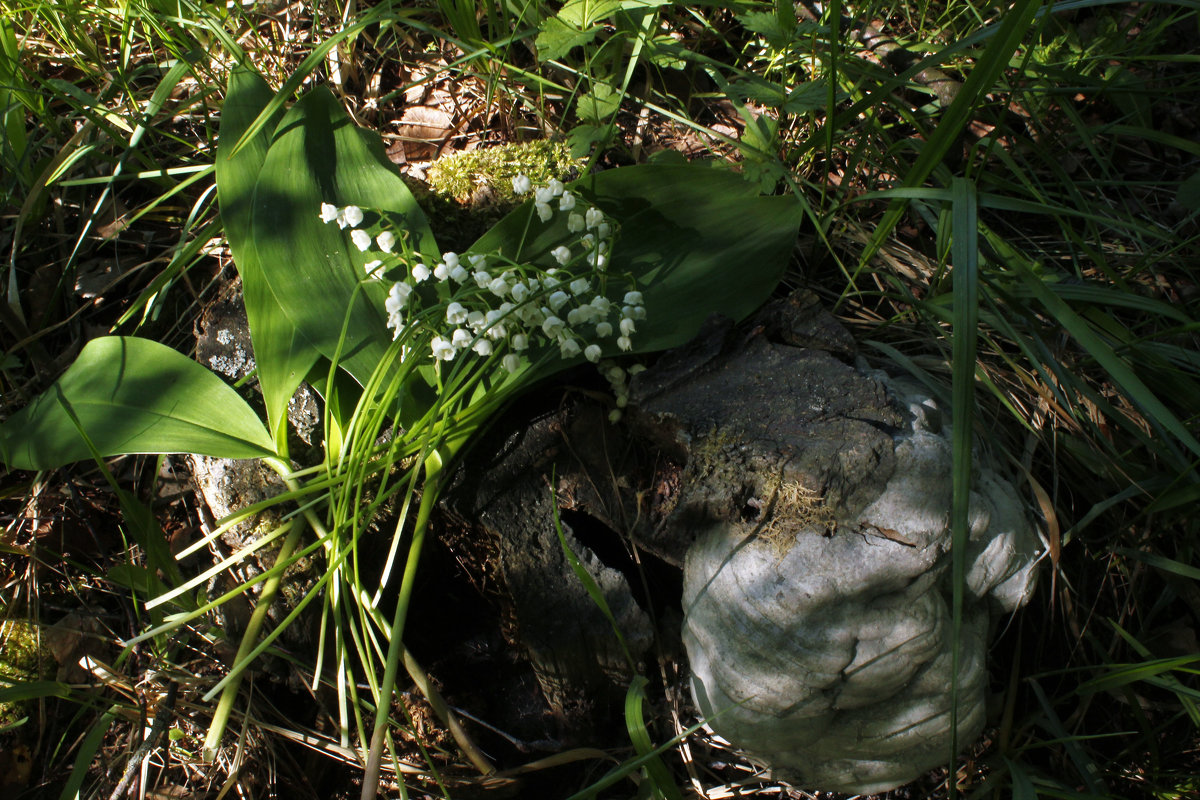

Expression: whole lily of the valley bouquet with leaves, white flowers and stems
xmin=0 ymin=65 xmax=799 ymax=796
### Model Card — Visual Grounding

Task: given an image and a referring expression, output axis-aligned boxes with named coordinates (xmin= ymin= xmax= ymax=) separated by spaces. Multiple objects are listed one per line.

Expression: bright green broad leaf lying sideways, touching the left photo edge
xmin=0 ymin=336 xmax=275 ymax=469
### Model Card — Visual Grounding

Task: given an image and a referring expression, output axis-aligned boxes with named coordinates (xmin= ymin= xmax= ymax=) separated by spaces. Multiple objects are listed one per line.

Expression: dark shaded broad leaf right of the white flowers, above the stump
xmin=472 ymin=166 xmax=800 ymax=355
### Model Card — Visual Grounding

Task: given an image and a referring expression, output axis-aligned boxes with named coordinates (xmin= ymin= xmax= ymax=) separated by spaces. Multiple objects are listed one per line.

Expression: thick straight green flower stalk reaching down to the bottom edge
xmin=362 ymin=452 xmax=443 ymax=800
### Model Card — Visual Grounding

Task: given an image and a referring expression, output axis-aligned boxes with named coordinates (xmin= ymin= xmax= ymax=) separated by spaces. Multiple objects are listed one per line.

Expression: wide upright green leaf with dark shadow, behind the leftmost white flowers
xmin=251 ymin=88 xmax=439 ymax=383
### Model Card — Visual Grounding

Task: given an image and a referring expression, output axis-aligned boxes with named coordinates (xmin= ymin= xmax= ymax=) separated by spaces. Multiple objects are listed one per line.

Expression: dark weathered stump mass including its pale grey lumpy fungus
xmin=448 ymin=291 xmax=1038 ymax=792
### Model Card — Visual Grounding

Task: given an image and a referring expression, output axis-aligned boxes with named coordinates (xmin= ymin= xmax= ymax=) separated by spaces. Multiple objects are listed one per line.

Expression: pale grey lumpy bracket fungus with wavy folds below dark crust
xmin=683 ymin=373 xmax=1039 ymax=793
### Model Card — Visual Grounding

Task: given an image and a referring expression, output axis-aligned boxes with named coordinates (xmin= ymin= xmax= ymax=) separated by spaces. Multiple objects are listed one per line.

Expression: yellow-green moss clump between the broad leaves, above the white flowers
xmin=409 ymin=140 xmax=582 ymax=253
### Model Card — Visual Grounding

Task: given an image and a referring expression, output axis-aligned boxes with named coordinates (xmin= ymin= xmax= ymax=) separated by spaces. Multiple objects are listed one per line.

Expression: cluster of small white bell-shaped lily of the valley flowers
xmin=320 ymin=175 xmax=646 ymax=372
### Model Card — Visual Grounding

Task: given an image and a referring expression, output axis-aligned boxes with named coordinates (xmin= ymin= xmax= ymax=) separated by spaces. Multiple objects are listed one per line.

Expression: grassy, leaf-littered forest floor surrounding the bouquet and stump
xmin=0 ymin=0 xmax=1200 ymax=800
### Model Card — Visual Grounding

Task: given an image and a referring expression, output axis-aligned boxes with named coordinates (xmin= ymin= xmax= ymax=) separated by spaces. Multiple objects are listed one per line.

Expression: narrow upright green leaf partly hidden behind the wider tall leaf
xmin=217 ymin=70 xmax=319 ymax=437
